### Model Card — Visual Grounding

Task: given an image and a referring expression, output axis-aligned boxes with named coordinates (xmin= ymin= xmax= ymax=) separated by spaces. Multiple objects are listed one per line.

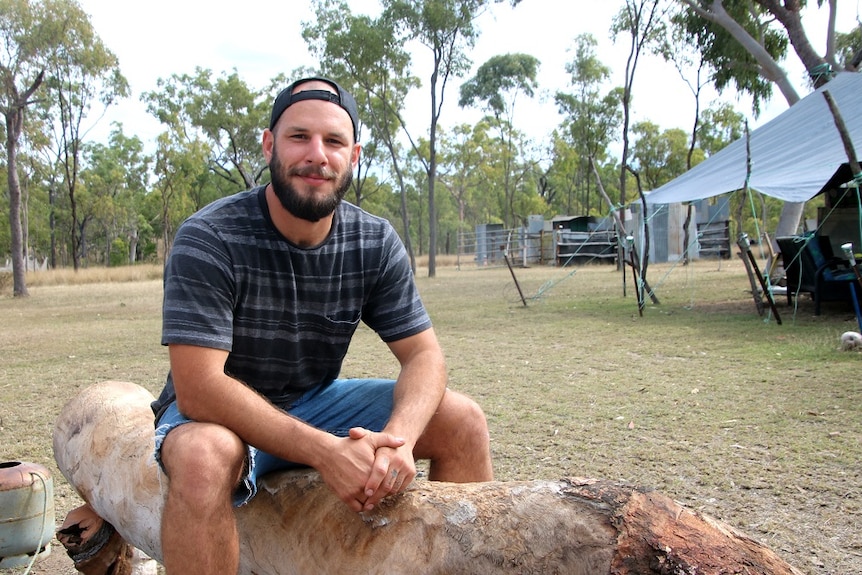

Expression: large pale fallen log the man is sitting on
xmin=54 ymin=382 xmax=801 ymax=575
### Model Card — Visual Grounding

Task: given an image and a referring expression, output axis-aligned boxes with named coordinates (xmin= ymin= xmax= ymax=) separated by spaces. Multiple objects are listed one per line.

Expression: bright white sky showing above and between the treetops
xmin=79 ymin=0 xmax=862 ymax=154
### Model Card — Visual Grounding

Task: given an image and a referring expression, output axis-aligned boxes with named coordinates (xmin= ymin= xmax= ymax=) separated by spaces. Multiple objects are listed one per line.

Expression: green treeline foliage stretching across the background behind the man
xmin=0 ymin=0 xmax=859 ymax=280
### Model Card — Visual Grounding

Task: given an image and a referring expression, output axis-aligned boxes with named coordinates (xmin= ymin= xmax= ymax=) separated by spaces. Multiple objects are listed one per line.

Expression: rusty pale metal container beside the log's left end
xmin=0 ymin=461 xmax=54 ymax=569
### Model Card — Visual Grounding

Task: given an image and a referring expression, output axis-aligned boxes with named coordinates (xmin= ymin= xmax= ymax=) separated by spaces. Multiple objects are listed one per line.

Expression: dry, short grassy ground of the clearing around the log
xmin=0 ymin=261 xmax=862 ymax=575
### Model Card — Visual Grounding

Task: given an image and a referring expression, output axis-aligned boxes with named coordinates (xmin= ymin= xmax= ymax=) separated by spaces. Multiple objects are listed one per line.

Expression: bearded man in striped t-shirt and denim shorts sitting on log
xmin=153 ymin=78 xmax=493 ymax=575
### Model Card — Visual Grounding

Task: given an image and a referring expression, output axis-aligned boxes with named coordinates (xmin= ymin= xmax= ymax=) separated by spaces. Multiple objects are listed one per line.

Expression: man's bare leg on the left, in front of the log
xmin=161 ymin=423 xmax=246 ymax=575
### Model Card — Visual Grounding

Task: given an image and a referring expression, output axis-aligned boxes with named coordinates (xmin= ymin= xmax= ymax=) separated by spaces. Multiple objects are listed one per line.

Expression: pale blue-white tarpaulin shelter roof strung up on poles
xmin=646 ymin=72 xmax=862 ymax=204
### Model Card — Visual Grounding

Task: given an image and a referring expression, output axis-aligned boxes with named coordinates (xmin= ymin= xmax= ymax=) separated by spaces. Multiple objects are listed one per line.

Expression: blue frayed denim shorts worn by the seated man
xmin=155 ymin=379 xmax=395 ymax=507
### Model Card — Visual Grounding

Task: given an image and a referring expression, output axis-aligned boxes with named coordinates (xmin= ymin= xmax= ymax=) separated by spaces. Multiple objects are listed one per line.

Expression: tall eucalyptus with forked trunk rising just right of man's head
xmin=304 ymin=0 xmax=518 ymax=277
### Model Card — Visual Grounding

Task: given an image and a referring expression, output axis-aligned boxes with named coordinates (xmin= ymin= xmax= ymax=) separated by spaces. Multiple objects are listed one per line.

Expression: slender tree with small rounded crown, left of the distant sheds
xmin=458 ymin=54 xmax=539 ymax=227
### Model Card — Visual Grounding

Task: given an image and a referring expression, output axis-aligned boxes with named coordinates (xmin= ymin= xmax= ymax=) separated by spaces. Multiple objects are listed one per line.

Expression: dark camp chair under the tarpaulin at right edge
xmin=775 ymin=234 xmax=858 ymax=315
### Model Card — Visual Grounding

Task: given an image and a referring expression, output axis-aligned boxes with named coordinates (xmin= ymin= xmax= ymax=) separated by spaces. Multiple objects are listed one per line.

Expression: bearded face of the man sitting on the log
xmin=264 ymin=82 xmax=359 ymax=222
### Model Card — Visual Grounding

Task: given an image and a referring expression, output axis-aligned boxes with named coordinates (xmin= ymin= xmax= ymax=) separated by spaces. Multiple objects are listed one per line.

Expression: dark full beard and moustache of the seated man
xmin=269 ymin=146 xmax=353 ymax=222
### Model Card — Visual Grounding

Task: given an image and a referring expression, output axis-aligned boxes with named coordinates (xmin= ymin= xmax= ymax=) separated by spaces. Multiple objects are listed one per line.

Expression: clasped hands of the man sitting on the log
xmin=318 ymin=427 xmax=416 ymax=512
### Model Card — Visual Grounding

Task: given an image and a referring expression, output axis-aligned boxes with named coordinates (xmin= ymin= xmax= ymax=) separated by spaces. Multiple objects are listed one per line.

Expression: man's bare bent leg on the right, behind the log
xmin=414 ymin=389 xmax=494 ymax=483
